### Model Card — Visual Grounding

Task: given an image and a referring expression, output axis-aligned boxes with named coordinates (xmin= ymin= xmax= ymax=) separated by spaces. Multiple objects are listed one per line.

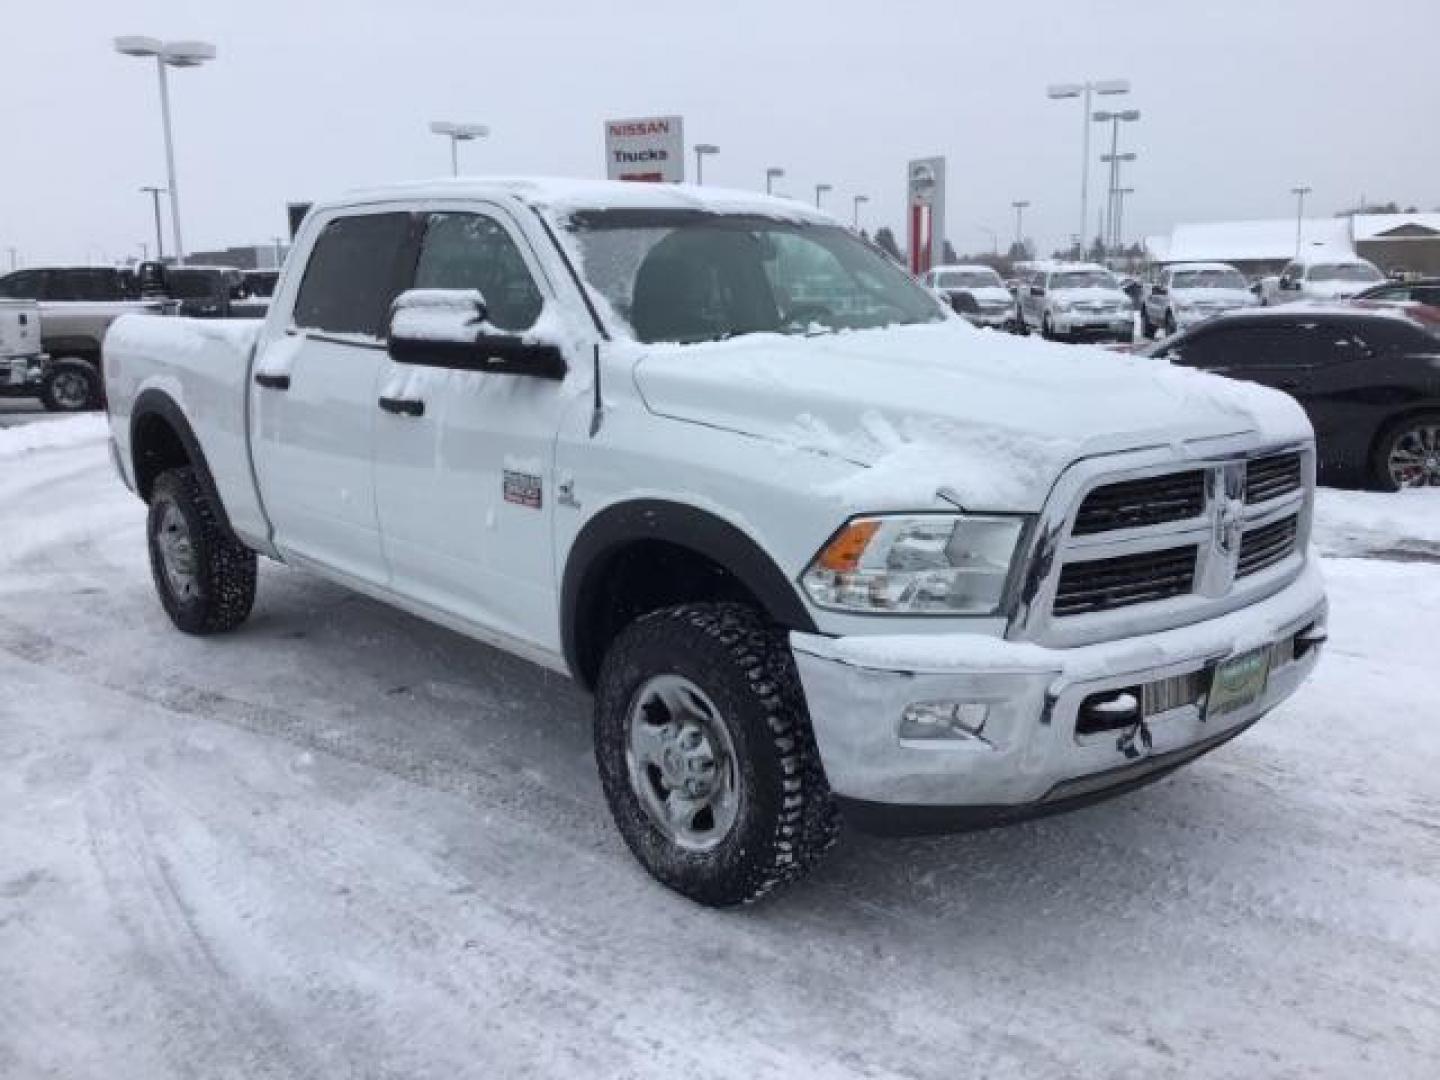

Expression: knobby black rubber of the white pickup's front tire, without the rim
xmin=595 ymin=603 xmax=840 ymax=907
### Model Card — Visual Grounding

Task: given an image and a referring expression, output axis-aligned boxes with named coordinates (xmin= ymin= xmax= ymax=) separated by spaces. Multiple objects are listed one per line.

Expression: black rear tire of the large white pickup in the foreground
xmin=145 ymin=468 xmax=256 ymax=634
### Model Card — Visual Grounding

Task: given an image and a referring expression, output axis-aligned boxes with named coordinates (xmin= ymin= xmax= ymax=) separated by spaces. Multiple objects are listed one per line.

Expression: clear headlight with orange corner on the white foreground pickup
xmin=801 ymin=514 xmax=1025 ymax=615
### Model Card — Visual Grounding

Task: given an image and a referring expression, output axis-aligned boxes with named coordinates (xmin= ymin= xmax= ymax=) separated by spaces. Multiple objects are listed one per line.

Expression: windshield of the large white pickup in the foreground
xmin=564 ymin=210 xmax=945 ymax=343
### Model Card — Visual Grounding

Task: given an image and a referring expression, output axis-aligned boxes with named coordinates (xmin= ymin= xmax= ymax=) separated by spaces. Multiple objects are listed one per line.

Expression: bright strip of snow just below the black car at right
xmin=1312 ymin=488 xmax=1440 ymax=559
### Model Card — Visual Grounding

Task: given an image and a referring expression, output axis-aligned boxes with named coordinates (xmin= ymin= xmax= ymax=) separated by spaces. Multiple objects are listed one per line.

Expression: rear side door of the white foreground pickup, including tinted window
xmin=251 ymin=209 xmax=415 ymax=583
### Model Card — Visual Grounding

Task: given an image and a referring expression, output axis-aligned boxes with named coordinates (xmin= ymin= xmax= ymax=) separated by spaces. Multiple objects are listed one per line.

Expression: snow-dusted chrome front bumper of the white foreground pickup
xmin=791 ymin=562 xmax=1326 ymax=831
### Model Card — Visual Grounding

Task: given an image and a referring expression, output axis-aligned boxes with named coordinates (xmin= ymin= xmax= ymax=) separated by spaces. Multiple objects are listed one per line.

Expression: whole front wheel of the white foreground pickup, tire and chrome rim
xmin=595 ymin=603 xmax=838 ymax=907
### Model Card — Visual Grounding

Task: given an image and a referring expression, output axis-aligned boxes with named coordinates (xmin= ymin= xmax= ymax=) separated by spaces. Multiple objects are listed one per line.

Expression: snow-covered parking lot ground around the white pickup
xmin=0 ymin=416 xmax=1440 ymax=1080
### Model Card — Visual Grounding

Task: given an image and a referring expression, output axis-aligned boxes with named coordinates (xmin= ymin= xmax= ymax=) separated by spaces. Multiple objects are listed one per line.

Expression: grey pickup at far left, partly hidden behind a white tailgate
xmin=0 ymin=266 xmax=163 ymax=412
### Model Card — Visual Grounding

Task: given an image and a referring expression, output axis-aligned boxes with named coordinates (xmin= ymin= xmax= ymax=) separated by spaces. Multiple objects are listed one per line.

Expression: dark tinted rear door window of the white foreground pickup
xmin=294 ymin=213 xmax=410 ymax=337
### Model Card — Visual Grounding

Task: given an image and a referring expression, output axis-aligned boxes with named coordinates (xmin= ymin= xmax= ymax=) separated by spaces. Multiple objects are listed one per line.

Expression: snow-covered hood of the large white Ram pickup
xmin=635 ymin=320 xmax=1310 ymax=511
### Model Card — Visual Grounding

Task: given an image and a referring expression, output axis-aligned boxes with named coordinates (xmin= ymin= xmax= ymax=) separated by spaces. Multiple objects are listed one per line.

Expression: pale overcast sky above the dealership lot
xmin=0 ymin=0 xmax=1440 ymax=269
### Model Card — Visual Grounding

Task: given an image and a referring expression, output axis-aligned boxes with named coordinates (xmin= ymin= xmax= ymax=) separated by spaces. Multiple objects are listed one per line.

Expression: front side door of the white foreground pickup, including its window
xmin=374 ymin=203 xmax=589 ymax=651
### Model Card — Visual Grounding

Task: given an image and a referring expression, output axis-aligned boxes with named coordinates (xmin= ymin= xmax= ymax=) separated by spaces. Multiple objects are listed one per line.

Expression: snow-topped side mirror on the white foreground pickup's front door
xmin=389 ymin=289 xmax=566 ymax=379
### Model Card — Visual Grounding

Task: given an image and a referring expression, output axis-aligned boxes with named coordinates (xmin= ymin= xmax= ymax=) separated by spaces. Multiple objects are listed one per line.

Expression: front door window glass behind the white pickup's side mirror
xmin=415 ymin=213 xmax=544 ymax=330
